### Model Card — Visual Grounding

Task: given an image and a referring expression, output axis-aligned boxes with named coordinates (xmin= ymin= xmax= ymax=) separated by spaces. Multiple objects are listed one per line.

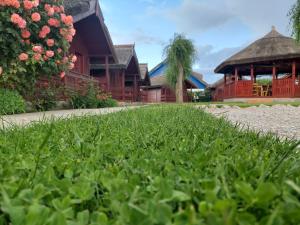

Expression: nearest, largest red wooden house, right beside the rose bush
xmin=64 ymin=0 xmax=118 ymax=94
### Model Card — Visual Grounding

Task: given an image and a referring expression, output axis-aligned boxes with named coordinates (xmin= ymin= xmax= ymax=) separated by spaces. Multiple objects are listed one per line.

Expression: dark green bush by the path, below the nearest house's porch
xmin=71 ymin=84 xmax=118 ymax=109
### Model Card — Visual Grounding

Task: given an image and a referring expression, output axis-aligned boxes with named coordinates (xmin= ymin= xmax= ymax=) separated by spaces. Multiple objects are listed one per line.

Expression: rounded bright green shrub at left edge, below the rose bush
xmin=0 ymin=89 xmax=26 ymax=115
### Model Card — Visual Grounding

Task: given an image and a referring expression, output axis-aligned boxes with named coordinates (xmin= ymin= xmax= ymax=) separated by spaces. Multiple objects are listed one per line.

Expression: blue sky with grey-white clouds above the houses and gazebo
xmin=100 ymin=0 xmax=296 ymax=83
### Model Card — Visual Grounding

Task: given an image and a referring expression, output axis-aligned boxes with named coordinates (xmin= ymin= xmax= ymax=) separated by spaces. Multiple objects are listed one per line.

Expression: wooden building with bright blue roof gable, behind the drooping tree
xmin=141 ymin=61 xmax=207 ymax=103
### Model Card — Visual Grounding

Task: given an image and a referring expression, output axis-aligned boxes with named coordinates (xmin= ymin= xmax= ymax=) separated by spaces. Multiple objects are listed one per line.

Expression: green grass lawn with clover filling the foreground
xmin=0 ymin=105 xmax=300 ymax=225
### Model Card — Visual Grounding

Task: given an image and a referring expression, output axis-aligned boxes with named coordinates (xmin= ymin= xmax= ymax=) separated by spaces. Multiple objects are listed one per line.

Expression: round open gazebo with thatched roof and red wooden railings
xmin=215 ymin=27 xmax=300 ymax=99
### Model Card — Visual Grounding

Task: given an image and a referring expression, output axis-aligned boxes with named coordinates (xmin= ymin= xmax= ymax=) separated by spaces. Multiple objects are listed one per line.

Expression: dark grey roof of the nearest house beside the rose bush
xmin=64 ymin=0 xmax=118 ymax=63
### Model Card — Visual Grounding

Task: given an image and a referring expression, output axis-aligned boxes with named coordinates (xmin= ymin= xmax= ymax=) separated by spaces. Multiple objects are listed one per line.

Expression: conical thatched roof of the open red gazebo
xmin=215 ymin=27 xmax=300 ymax=73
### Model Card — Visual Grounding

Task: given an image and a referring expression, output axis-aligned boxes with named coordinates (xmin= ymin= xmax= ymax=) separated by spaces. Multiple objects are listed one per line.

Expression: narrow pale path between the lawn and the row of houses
xmin=0 ymin=106 xmax=138 ymax=128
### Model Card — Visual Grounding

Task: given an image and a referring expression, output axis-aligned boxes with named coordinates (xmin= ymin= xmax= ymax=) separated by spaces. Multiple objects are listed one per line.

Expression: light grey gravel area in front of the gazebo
xmin=200 ymin=105 xmax=300 ymax=140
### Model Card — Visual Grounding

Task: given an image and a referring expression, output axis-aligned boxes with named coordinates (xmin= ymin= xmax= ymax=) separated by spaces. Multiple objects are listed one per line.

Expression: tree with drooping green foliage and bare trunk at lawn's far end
xmin=164 ymin=34 xmax=196 ymax=103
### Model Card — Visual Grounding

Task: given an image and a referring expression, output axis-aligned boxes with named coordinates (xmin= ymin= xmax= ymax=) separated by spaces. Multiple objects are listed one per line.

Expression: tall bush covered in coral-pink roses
xmin=0 ymin=0 xmax=76 ymax=93
